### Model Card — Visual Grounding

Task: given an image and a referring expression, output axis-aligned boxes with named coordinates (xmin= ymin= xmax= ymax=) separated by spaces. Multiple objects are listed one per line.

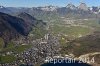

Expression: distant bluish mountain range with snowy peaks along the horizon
xmin=0 ymin=3 xmax=100 ymax=21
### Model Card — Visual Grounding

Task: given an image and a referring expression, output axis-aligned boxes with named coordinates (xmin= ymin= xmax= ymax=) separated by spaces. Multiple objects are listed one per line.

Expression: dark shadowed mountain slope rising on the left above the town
xmin=0 ymin=12 xmax=45 ymax=47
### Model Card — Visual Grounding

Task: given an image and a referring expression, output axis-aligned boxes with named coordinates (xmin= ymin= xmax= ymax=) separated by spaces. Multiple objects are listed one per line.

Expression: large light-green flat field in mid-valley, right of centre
xmin=52 ymin=25 xmax=91 ymax=38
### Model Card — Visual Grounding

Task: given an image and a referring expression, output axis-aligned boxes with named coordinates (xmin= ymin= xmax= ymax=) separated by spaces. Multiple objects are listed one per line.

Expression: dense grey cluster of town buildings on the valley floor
xmin=0 ymin=34 xmax=60 ymax=66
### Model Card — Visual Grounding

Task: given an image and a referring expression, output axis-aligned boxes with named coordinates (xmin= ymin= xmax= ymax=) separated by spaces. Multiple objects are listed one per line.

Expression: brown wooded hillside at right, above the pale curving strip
xmin=62 ymin=32 xmax=100 ymax=56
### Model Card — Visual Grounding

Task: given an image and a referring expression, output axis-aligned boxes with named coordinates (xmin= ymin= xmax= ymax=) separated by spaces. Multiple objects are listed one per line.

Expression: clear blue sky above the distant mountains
xmin=0 ymin=0 xmax=100 ymax=7
